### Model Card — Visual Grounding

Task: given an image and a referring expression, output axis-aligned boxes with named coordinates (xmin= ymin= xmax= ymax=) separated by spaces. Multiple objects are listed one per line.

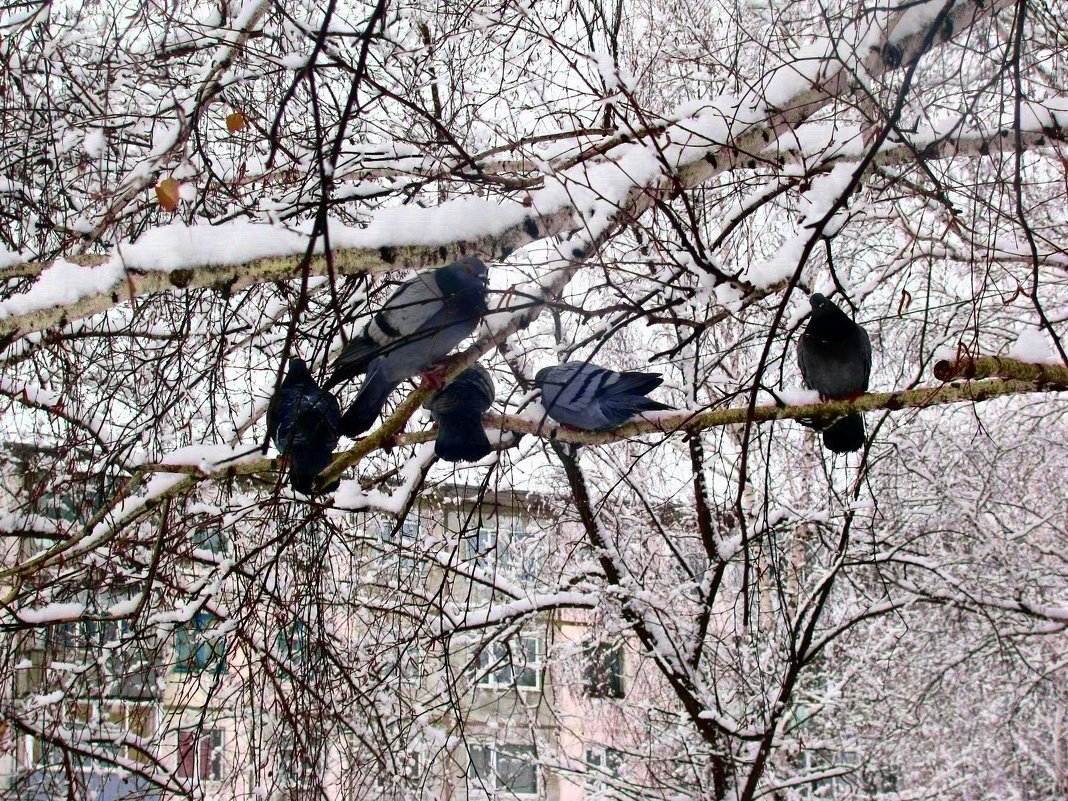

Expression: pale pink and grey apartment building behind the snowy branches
xmin=0 ymin=445 xmax=636 ymax=801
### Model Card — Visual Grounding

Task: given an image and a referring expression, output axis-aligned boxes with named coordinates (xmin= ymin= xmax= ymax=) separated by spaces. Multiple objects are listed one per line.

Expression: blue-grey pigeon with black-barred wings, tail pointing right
xmin=534 ymin=362 xmax=671 ymax=431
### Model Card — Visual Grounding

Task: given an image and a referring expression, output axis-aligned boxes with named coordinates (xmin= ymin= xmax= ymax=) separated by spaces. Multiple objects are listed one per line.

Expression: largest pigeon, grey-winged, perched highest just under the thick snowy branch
xmin=326 ymin=256 xmax=487 ymax=437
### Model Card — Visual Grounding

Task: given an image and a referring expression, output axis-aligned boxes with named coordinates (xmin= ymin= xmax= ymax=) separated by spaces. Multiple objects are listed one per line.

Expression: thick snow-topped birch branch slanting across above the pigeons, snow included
xmin=0 ymin=0 xmax=1008 ymax=342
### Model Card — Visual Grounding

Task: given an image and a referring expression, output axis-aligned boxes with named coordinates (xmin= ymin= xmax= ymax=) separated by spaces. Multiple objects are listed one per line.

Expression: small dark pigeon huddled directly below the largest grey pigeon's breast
xmin=425 ymin=364 xmax=494 ymax=461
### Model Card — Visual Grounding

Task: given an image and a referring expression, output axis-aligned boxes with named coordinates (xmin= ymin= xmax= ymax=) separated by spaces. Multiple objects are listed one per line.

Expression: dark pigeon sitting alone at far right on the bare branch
xmin=798 ymin=293 xmax=871 ymax=453
